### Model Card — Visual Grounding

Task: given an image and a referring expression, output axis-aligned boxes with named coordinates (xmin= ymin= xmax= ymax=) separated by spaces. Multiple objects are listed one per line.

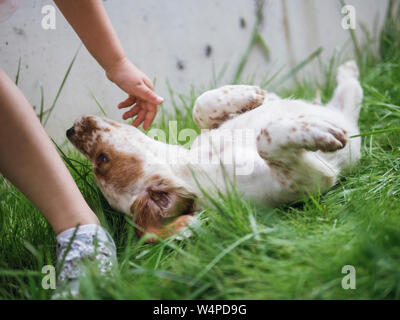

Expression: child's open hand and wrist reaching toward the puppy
xmin=106 ymin=58 xmax=164 ymax=130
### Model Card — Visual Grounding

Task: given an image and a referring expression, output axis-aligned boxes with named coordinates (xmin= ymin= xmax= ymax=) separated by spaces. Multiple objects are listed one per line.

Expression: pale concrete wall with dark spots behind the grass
xmin=0 ymin=0 xmax=387 ymax=142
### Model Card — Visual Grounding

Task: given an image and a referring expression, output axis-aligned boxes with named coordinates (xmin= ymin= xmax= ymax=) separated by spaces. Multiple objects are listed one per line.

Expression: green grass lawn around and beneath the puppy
xmin=0 ymin=9 xmax=400 ymax=299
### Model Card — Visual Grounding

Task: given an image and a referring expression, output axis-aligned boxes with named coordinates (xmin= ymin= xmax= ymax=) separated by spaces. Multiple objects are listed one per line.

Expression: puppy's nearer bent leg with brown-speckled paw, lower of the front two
xmin=257 ymin=116 xmax=347 ymax=193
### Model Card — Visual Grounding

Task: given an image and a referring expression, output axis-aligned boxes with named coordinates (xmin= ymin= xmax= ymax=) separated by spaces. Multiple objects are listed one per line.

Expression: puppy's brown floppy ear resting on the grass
xmin=131 ymin=180 xmax=195 ymax=241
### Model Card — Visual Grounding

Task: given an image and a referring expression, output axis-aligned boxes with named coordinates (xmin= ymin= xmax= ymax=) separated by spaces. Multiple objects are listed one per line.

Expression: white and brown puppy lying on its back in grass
xmin=67 ymin=61 xmax=362 ymax=240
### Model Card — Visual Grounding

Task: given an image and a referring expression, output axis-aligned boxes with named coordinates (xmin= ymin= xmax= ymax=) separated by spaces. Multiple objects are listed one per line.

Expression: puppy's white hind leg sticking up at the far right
xmin=327 ymin=60 xmax=363 ymax=121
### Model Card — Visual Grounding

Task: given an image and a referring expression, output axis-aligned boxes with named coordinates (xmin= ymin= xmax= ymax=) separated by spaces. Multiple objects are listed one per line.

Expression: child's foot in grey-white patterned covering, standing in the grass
xmin=53 ymin=224 xmax=117 ymax=298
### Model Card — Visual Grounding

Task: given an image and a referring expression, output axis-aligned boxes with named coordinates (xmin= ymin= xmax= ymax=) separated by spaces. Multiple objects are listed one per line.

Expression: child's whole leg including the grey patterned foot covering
xmin=0 ymin=70 xmax=116 ymax=294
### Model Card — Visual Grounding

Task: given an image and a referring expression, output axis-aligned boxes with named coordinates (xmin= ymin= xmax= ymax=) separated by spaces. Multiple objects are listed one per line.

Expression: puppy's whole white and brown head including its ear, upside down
xmin=66 ymin=116 xmax=194 ymax=241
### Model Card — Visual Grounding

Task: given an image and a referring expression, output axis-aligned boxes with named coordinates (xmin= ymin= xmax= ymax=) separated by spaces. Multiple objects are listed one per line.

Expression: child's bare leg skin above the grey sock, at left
xmin=0 ymin=70 xmax=99 ymax=234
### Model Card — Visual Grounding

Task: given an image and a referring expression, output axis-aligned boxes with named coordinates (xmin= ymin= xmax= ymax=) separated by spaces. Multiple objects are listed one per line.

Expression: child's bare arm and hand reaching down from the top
xmin=55 ymin=0 xmax=163 ymax=129
